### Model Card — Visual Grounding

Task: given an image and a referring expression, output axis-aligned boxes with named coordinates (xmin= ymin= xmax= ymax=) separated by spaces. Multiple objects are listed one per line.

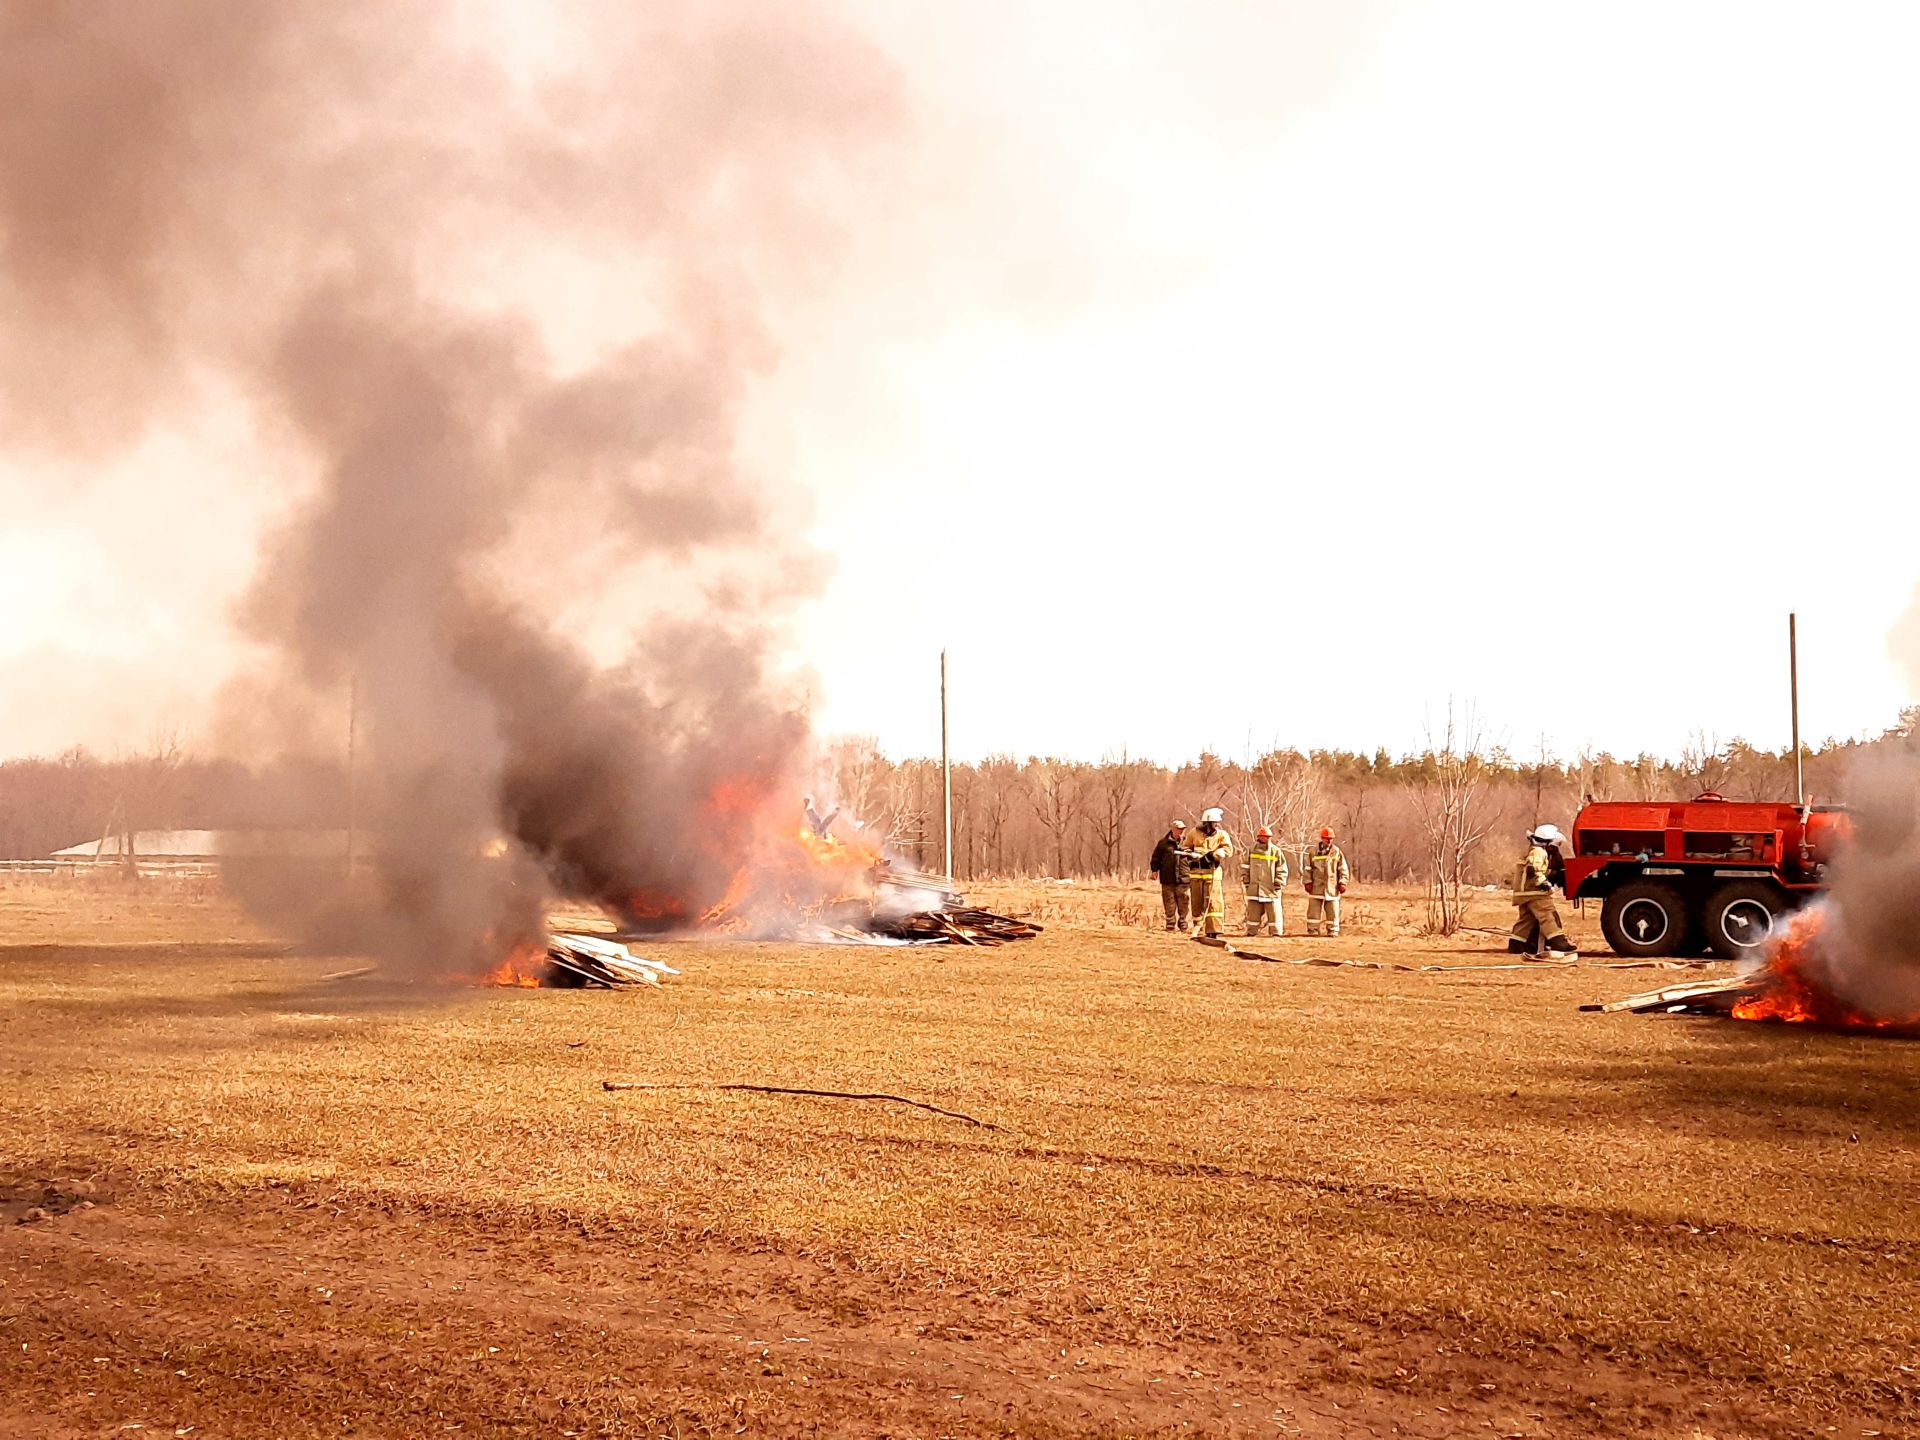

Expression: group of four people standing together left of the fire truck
xmin=1148 ymin=806 xmax=1352 ymax=939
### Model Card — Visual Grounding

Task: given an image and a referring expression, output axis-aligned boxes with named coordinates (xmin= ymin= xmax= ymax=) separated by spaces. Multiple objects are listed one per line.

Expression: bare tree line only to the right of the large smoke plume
xmin=817 ymin=707 xmax=1920 ymax=890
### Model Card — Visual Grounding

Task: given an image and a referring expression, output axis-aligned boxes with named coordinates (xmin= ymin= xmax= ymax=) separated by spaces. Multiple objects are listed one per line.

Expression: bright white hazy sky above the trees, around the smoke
xmin=0 ymin=0 xmax=1920 ymax=760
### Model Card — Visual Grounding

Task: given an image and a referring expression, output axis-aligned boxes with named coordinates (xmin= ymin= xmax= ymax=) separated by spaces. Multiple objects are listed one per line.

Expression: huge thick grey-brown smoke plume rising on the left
xmin=0 ymin=0 xmax=895 ymax=966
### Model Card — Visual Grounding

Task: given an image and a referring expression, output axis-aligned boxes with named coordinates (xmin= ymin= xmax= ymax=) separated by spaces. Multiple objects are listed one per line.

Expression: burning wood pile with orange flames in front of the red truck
xmin=1580 ymin=908 xmax=1920 ymax=1037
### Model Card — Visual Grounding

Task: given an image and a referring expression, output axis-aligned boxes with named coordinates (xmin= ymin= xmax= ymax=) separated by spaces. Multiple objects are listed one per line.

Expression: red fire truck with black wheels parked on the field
xmin=1567 ymin=791 xmax=1851 ymax=960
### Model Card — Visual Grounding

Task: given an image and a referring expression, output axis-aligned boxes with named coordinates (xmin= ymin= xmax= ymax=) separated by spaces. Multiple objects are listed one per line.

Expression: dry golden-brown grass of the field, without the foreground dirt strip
xmin=0 ymin=885 xmax=1920 ymax=1434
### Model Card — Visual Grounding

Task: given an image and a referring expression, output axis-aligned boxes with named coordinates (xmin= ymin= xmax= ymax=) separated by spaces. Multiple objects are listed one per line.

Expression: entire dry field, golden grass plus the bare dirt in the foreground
xmin=0 ymin=885 xmax=1920 ymax=1436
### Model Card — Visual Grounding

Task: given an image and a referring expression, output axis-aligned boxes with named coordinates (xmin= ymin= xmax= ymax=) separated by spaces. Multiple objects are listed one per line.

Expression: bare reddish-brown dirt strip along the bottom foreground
xmin=0 ymin=1194 xmax=1827 ymax=1436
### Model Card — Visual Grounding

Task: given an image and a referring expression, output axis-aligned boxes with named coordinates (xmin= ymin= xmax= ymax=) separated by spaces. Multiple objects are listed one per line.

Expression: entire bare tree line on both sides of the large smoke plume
xmin=0 ymin=708 xmax=1920 ymax=879
